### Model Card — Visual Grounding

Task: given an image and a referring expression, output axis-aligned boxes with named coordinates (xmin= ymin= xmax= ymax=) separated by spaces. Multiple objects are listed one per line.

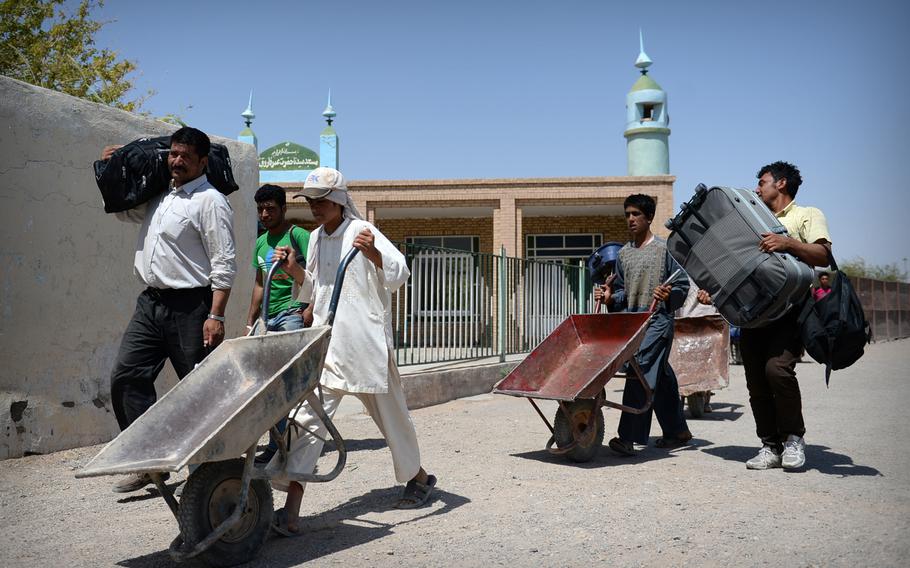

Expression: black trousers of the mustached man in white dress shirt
xmin=111 ymin=288 xmax=212 ymax=430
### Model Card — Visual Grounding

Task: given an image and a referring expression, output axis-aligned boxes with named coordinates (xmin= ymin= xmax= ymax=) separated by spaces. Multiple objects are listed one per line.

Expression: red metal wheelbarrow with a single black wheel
xmin=493 ymin=271 xmax=678 ymax=462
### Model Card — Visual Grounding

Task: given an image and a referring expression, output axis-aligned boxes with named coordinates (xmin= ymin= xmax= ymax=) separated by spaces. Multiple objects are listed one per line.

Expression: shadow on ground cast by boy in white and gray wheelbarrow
xmin=118 ymin=486 xmax=470 ymax=568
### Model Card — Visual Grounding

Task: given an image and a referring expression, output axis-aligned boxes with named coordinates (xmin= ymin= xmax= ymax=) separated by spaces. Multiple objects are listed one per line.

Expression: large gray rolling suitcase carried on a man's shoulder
xmin=667 ymin=184 xmax=813 ymax=328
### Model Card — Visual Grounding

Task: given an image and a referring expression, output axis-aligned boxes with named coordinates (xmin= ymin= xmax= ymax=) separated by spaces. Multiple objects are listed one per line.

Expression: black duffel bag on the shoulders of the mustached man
xmin=94 ymin=136 xmax=240 ymax=213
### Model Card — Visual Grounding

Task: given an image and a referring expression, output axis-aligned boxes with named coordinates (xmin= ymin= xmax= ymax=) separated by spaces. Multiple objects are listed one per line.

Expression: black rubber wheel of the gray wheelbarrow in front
xmin=177 ymin=459 xmax=274 ymax=566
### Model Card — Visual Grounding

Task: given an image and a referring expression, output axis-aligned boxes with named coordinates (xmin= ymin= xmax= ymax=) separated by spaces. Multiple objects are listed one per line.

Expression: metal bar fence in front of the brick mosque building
xmin=392 ymin=243 xmax=591 ymax=365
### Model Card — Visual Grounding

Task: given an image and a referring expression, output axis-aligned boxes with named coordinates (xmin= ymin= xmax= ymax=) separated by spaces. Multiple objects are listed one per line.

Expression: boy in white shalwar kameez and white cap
xmin=270 ymin=168 xmax=436 ymax=536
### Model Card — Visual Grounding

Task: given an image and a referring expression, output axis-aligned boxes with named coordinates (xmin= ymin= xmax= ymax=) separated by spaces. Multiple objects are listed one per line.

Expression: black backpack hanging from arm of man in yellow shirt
xmin=798 ymin=253 xmax=872 ymax=385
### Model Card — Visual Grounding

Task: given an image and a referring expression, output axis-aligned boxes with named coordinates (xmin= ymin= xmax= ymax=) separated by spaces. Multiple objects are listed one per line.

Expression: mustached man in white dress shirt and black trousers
xmin=101 ymin=127 xmax=237 ymax=493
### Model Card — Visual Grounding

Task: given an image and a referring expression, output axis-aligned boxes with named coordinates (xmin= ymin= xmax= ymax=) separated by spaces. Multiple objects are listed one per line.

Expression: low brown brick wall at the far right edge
xmin=850 ymin=278 xmax=910 ymax=341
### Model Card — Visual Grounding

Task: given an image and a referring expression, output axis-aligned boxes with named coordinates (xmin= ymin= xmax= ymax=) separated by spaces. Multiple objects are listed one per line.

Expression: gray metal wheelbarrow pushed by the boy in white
xmin=76 ymin=249 xmax=358 ymax=566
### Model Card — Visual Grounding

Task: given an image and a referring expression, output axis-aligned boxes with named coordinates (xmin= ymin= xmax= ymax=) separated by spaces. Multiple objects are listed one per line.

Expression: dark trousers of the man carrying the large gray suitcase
xmin=740 ymin=309 xmax=806 ymax=449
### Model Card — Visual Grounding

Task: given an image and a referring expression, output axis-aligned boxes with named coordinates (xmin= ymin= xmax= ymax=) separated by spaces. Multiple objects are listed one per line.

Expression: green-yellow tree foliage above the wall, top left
xmin=0 ymin=0 xmax=150 ymax=111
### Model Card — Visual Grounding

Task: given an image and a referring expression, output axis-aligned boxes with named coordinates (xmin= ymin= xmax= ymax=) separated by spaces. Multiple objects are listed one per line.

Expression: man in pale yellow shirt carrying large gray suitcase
xmin=699 ymin=162 xmax=831 ymax=469
